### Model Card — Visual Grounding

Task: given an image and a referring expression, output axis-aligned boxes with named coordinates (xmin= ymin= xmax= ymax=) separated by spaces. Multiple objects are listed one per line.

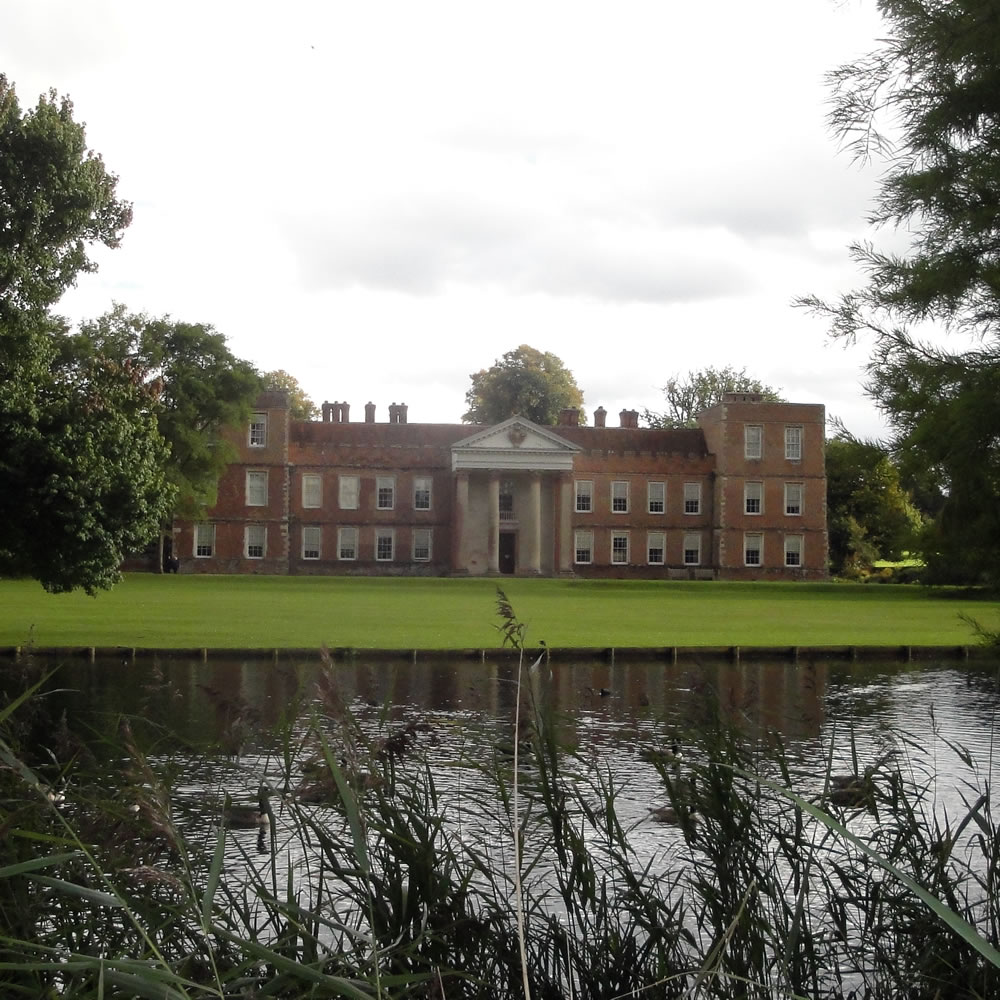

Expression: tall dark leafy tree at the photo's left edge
xmin=0 ymin=82 xmax=173 ymax=593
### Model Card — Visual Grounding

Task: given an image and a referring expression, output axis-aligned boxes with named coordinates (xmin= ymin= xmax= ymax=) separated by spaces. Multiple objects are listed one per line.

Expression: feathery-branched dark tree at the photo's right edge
xmin=802 ymin=0 xmax=1000 ymax=583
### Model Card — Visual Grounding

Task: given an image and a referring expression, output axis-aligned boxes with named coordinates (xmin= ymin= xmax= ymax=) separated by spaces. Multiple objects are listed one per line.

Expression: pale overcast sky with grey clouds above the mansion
xmin=0 ymin=0 xmax=896 ymax=435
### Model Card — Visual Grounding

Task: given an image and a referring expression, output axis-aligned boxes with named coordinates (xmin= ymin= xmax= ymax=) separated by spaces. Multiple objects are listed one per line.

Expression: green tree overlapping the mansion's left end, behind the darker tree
xmin=72 ymin=305 xmax=262 ymax=519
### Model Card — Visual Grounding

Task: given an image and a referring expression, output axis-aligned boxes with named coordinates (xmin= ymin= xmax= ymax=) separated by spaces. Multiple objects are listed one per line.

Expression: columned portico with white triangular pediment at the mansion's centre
xmin=451 ymin=417 xmax=580 ymax=576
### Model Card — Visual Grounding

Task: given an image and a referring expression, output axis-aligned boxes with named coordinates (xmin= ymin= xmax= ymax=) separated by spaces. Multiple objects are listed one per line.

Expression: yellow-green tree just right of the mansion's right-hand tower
xmin=826 ymin=426 xmax=922 ymax=573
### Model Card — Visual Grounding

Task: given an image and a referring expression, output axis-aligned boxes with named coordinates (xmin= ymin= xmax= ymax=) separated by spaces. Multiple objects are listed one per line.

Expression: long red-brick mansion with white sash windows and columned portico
xmin=173 ymin=392 xmax=827 ymax=580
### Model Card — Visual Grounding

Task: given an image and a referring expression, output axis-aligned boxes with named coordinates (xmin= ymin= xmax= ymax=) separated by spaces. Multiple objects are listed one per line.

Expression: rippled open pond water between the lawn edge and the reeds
xmin=13 ymin=659 xmax=1000 ymax=854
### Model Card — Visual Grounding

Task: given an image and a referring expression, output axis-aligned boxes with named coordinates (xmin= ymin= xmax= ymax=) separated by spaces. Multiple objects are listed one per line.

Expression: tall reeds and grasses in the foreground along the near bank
xmin=0 ymin=596 xmax=1000 ymax=1000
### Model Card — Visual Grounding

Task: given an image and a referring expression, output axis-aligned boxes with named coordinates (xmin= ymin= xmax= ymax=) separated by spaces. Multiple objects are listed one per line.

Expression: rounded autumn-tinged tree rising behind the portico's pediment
xmin=462 ymin=344 xmax=586 ymax=424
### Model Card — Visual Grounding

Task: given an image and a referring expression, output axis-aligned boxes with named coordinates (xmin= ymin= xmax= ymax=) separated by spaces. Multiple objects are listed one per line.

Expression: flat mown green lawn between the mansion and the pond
xmin=0 ymin=574 xmax=1000 ymax=649
